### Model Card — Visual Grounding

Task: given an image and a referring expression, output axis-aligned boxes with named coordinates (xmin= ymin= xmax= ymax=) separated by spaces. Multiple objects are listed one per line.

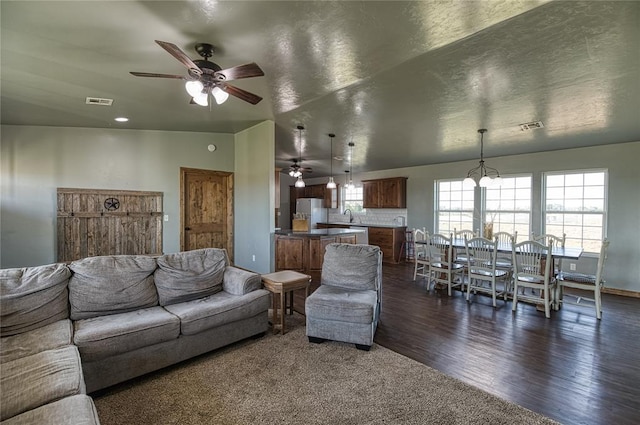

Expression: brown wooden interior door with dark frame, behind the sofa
xmin=180 ymin=168 xmax=233 ymax=261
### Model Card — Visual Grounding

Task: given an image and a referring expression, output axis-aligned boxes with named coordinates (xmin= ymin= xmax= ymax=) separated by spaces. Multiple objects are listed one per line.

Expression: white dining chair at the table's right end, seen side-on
xmin=556 ymin=239 xmax=609 ymax=319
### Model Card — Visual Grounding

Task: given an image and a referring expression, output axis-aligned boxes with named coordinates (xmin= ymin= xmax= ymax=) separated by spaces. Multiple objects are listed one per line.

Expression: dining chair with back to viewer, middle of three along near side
xmin=464 ymin=238 xmax=509 ymax=308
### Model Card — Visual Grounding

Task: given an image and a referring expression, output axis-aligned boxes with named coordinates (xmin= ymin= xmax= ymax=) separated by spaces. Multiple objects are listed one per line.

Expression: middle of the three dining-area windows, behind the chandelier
xmin=484 ymin=175 xmax=531 ymax=242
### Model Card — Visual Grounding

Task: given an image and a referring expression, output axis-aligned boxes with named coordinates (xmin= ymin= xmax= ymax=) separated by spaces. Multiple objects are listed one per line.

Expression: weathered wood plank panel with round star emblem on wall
xmin=57 ymin=188 xmax=163 ymax=262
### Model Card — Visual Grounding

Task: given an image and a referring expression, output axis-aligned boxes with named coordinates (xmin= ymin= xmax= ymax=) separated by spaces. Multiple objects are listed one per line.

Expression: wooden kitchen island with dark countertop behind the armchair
xmin=275 ymin=229 xmax=364 ymax=274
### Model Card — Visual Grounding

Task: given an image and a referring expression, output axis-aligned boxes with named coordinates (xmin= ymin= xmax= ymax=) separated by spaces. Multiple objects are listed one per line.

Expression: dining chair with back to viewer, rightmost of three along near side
xmin=511 ymin=240 xmax=557 ymax=319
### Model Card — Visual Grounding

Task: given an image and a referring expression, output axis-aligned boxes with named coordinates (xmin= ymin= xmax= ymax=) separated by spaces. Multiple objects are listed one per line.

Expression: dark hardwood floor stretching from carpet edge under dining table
xmin=296 ymin=263 xmax=640 ymax=425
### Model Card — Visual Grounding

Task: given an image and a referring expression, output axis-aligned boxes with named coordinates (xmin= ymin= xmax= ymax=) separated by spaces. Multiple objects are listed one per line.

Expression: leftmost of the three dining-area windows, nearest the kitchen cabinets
xmin=435 ymin=180 xmax=474 ymax=235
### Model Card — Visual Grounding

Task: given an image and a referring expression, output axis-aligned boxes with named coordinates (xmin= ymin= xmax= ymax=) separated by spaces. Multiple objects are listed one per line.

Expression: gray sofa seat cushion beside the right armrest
xmin=165 ymin=289 xmax=269 ymax=335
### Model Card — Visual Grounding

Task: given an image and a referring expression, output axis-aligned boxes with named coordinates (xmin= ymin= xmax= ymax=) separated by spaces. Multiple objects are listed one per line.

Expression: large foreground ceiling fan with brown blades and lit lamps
xmin=130 ymin=40 xmax=264 ymax=106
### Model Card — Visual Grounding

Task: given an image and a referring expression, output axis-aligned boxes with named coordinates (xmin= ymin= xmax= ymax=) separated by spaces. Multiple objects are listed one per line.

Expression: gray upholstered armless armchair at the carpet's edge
xmin=305 ymin=243 xmax=382 ymax=350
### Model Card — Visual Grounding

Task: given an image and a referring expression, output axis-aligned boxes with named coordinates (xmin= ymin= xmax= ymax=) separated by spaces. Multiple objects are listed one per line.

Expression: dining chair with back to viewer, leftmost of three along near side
xmin=427 ymin=234 xmax=464 ymax=296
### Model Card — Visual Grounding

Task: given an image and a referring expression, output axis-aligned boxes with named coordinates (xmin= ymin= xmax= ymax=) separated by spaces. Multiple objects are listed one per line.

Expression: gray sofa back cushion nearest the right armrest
xmin=154 ymin=248 xmax=227 ymax=306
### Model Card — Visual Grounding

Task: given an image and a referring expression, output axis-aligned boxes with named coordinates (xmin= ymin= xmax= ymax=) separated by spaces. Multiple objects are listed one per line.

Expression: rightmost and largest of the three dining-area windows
xmin=544 ymin=170 xmax=608 ymax=252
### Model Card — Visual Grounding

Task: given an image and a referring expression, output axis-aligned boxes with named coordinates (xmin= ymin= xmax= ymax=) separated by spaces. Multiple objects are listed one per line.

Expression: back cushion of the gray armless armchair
xmin=321 ymin=243 xmax=380 ymax=290
